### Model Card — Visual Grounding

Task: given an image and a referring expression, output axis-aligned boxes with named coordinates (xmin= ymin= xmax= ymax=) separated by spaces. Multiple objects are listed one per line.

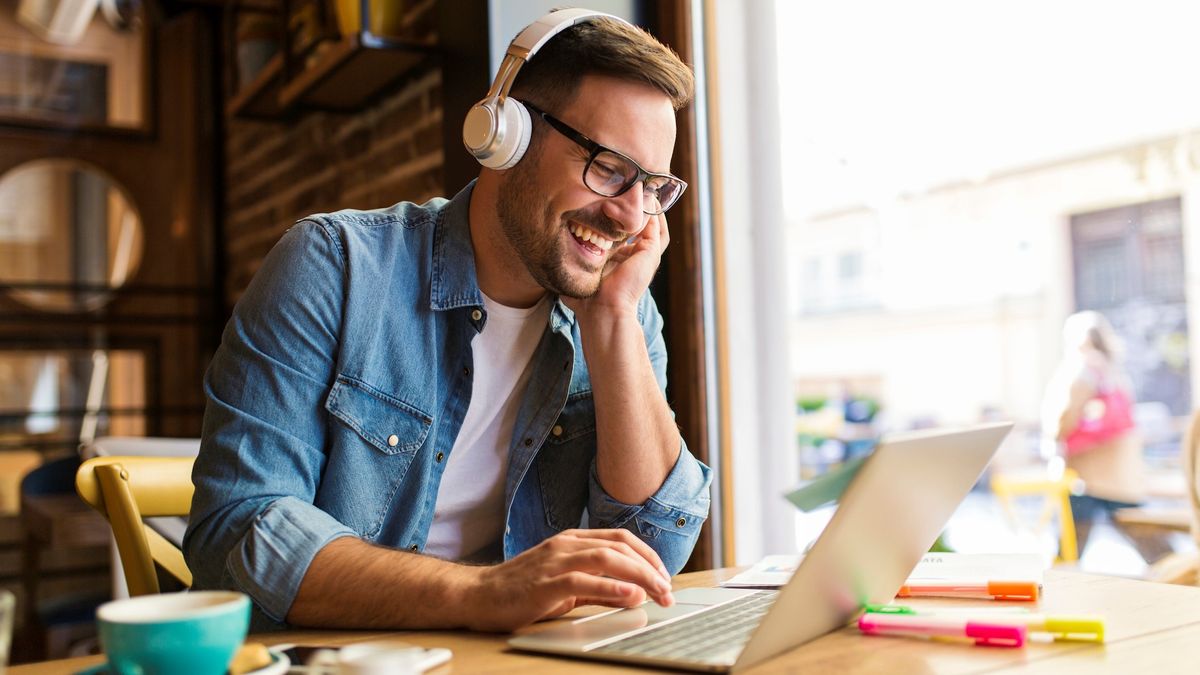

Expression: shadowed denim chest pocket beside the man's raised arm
xmin=538 ymin=392 xmax=596 ymax=531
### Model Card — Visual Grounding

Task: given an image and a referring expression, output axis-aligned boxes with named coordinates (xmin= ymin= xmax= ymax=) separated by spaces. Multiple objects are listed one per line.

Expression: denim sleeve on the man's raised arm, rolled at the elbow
xmin=588 ymin=292 xmax=713 ymax=574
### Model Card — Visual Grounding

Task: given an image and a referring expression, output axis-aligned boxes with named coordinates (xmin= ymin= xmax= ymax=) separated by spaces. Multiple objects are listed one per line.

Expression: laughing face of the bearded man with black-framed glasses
xmin=497 ymin=76 xmax=676 ymax=298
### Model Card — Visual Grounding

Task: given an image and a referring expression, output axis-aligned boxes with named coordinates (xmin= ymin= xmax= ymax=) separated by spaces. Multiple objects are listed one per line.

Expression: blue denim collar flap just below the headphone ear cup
xmin=430 ymin=180 xmax=484 ymax=310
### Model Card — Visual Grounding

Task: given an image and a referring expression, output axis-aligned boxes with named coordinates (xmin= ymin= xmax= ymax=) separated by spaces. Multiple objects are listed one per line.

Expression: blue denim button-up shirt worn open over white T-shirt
xmin=184 ymin=185 xmax=712 ymax=629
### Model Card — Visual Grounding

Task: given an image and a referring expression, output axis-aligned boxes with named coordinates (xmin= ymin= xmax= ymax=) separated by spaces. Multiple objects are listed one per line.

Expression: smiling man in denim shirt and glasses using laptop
xmin=184 ymin=11 xmax=710 ymax=631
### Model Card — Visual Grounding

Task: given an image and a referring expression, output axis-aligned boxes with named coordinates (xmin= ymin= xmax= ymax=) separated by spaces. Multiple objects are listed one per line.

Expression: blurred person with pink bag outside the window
xmin=1042 ymin=311 xmax=1171 ymax=563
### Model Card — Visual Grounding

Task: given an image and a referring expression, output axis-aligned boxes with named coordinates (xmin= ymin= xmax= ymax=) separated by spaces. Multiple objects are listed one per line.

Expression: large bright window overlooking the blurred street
xmin=714 ymin=0 xmax=1200 ymax=564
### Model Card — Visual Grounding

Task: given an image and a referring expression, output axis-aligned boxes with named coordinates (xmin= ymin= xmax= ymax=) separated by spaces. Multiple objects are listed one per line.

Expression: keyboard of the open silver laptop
xmin=592 ymin=591 xmax=779 ymax=663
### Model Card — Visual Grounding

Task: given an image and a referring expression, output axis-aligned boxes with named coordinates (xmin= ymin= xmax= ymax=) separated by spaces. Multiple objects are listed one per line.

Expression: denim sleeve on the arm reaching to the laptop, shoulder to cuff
xmin=184 ymin=221 xmax=356 ymax=621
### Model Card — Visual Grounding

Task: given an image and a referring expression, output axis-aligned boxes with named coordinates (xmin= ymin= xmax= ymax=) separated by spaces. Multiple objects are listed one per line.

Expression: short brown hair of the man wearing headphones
xmin=512 ymin=17 xmax=694 ymax=112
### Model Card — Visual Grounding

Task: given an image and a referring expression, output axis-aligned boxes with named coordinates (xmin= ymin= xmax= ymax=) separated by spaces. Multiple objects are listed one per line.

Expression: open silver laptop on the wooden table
xmin=509 ymin=423 xmax=1013 ymax=673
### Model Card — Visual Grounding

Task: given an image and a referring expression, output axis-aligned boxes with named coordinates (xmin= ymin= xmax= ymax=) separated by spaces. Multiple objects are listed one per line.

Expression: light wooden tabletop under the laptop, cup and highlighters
xmin=8 ymin=569 xmax=1200 ymax=675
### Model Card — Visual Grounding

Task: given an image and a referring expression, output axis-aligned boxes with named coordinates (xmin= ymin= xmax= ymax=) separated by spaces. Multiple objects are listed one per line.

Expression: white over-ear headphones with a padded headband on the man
xmin=462 ymin=10 xmax=629 ymax=169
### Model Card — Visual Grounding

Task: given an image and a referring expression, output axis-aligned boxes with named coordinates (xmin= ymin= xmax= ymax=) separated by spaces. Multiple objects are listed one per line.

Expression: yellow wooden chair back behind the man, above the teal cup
xmin=76 ymin=456 xmax=196 ymax=597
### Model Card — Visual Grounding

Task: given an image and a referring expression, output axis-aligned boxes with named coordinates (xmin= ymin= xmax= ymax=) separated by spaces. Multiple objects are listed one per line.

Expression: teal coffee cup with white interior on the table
xmin=96 ymin=591 xmax=250 ymax=675
